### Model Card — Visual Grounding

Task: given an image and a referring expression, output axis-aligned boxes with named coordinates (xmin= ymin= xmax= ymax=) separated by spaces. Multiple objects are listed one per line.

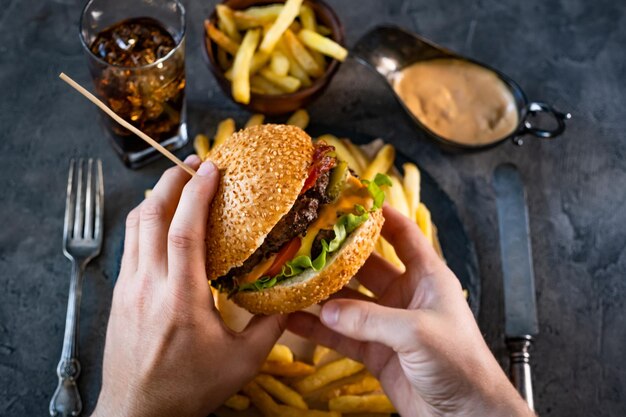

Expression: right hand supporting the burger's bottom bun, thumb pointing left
xmin=288 ymin=206 xmax=533 ymax=417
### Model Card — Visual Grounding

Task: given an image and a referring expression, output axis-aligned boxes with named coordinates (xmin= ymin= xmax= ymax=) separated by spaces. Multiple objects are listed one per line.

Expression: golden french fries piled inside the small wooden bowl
xmin=204 ymin=0 xmax=348 ymax=104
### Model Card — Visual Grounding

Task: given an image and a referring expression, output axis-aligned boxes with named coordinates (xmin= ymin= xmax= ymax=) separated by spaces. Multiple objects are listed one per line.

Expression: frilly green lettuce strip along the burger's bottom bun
xmin=230 ymin=174 xmax=391 ymax=295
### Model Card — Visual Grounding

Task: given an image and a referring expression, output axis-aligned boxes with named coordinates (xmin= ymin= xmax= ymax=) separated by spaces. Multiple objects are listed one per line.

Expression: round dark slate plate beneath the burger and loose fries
xmin=307 ymin=125 xmax=480 ymax=317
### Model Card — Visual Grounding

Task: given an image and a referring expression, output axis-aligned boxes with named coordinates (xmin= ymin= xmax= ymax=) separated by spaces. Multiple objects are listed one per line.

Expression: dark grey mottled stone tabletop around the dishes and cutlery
xmin=0 ymin=0 xmax=626 ymax=416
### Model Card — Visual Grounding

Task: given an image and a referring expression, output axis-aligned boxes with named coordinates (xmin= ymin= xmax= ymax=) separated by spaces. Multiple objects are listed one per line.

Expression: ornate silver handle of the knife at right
xmin=506 ymin=335 xmax=535 ymax=411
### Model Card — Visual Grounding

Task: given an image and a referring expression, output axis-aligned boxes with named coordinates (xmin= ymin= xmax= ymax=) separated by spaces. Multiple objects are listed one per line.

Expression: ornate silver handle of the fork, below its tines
xmin=50 ymin=260 xmax=85 ymax=417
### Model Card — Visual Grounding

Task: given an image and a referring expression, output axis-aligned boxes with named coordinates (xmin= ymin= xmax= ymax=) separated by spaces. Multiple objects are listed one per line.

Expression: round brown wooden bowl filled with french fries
xmin=204 ymin=0 xmax=347 ymax=115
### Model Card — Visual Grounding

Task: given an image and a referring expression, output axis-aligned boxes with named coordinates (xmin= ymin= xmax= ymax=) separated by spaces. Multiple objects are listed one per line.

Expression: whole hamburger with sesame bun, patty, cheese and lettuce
xmin=206 ymin=124 xmax=390 ymax=314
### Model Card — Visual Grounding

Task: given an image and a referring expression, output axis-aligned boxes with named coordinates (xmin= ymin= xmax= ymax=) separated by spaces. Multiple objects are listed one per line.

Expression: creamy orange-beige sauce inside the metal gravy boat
xmin=393 ymin=58 xmax=518 ymax=145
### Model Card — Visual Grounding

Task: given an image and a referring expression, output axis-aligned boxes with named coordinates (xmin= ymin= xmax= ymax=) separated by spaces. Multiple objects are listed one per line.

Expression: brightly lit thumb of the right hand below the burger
xmin=320 ymin=300 xmax=420 ymax=352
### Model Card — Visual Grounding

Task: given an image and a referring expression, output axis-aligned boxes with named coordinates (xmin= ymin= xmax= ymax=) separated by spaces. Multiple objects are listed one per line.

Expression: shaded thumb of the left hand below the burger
xmin=238 ymin=314 xmax=287 ymax=369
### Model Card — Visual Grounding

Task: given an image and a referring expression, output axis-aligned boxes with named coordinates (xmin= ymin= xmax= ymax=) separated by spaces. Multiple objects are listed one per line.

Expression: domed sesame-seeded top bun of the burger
xmin=206 ymin=124 xmax=313 ymax=280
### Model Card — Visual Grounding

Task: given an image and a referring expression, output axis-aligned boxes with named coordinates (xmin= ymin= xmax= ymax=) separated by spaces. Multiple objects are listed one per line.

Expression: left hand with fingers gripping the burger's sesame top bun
xmin=94 ymin=156 xmax=284 ymax=417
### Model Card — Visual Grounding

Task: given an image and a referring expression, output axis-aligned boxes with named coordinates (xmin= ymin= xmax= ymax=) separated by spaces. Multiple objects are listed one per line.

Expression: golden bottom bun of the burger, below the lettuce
xmin=233 ymin=210 xmax=385 ymax=314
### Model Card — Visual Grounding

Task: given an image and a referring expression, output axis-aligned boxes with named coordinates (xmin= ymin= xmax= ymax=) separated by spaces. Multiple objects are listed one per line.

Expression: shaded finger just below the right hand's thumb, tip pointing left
xmin=287 ymin=311 xmax=363 ymax=362
